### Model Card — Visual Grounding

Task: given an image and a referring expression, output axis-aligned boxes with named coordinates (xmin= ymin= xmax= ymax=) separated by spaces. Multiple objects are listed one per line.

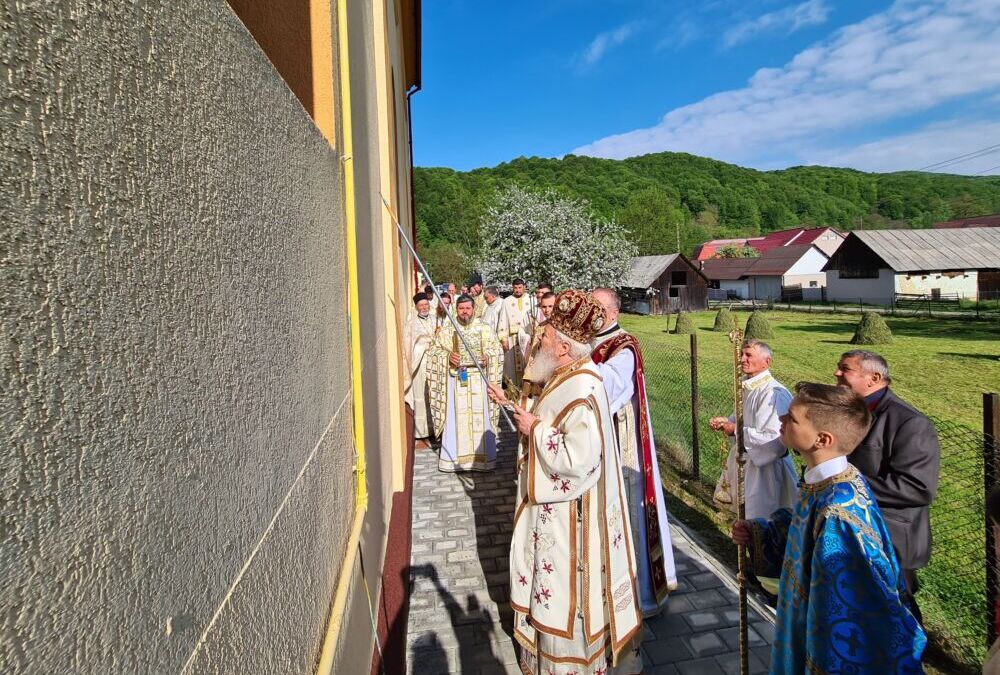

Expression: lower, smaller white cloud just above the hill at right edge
xmin=807 ymin=120 xmax=1000 ymax=176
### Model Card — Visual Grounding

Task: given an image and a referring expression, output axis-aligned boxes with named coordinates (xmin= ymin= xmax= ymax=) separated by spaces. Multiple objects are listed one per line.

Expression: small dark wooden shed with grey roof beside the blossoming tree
xmin=621 ymin=253 xmax=708 ymax=314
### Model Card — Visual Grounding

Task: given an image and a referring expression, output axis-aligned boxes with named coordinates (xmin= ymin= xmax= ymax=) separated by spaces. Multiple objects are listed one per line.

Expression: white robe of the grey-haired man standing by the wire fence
xmin=715 ymin=370 xmax=799 ymax=519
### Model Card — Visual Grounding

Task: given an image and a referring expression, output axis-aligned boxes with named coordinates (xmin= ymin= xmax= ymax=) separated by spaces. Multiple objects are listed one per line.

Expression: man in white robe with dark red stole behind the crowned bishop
xmin=590 ymin=288 xmax=677 ymax=617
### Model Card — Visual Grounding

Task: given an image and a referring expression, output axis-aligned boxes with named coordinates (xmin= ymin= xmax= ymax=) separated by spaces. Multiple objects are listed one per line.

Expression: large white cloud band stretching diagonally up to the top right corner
xmin=573 ymin=0 xmax=1000 ymax=166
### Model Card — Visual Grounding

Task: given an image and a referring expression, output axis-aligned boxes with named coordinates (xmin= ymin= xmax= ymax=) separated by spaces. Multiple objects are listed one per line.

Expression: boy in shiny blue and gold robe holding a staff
xmin=732 ymin=382 xmax=927 ymax=675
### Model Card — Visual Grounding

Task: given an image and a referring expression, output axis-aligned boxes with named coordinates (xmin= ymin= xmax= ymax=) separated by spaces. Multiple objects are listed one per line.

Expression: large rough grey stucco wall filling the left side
xmin=0 ymin=0 xmax=353 ymax=674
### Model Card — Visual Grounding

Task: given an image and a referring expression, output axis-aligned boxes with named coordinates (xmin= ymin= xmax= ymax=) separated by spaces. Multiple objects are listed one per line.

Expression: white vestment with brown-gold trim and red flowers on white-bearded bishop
xmin=510 ymin=358 xmax=642 ymax=675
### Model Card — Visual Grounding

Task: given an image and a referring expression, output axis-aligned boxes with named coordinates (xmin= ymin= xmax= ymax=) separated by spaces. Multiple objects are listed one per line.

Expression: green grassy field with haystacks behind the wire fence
xmin=622 ymin=311 xmax=1000 ymax=672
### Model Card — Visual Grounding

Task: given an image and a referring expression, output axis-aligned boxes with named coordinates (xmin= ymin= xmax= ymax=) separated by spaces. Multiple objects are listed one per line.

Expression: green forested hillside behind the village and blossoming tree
xmin=414 ymin=152 xmax=1000 ymax=277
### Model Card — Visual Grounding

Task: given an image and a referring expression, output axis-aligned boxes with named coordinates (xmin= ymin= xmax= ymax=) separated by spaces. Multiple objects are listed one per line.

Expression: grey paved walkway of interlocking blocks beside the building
xmin=404 ymin=435 xmax=774 ymax=675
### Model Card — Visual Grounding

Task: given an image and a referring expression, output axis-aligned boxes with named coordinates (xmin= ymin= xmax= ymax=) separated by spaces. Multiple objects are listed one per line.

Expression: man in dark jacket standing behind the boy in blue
xmin=835 ymin=349 xmax=941 ymax=622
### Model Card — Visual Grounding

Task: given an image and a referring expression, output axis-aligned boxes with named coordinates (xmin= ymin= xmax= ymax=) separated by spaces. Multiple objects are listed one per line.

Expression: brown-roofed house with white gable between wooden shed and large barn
xmin=701 ymin=244 xmax=829 ymax=300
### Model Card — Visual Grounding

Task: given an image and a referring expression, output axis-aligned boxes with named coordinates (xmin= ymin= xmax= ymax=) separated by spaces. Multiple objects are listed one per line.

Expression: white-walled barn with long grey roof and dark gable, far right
xmin=824 ymin=227 xmax=1000 ymax=305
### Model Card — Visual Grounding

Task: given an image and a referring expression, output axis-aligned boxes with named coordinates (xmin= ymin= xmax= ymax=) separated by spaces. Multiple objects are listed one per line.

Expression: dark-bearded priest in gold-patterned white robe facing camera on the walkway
xmin=427 ymin=295 xmax=501 ymax=472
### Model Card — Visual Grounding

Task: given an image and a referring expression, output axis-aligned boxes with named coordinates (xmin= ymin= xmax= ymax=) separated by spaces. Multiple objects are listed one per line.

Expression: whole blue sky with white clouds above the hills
xmin=413 ymin=0 xmax=1000 ymax=174
